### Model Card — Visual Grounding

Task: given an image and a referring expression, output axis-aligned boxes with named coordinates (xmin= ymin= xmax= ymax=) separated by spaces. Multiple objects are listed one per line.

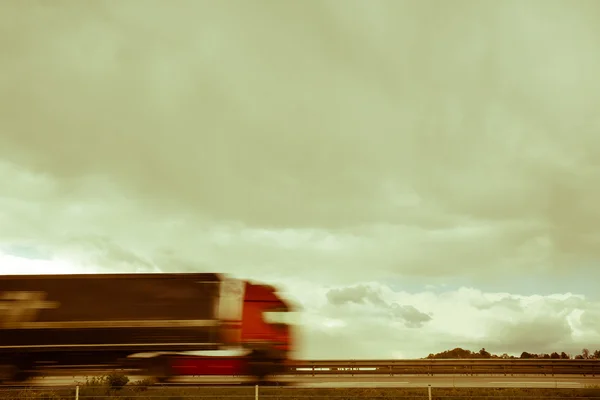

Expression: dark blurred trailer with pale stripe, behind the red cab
xmin=0 ymin=273 xmax=222 ymax=378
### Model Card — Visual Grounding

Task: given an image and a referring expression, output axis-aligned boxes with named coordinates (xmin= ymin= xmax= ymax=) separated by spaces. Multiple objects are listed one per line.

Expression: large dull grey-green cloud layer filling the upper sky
xmin=1 ymin=2 xmax=599 ymax=231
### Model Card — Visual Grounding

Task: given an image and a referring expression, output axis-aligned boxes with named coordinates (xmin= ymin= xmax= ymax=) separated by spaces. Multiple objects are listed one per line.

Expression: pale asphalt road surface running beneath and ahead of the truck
xmin=21 ymin=374 xmax=600 ymax=388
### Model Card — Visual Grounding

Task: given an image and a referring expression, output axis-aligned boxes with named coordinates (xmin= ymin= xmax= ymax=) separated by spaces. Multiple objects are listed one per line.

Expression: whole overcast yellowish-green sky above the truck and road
xmin=0 ymin=0 xmax=600 ymax=359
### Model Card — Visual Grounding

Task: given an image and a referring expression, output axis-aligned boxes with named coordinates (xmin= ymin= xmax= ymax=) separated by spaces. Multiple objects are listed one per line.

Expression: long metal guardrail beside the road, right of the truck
xmin=287 ymin=359 xmax=600 ymax=376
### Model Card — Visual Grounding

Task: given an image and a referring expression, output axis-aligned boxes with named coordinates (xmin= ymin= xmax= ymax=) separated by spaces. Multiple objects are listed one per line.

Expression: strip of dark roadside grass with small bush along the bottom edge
xmin=0 ymin=374 xmax=600 ymax=400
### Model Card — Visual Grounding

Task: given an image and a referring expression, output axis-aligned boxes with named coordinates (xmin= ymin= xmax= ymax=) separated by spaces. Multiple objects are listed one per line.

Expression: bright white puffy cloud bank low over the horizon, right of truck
xmin=296 ymin=284 xmax=600 ymax=358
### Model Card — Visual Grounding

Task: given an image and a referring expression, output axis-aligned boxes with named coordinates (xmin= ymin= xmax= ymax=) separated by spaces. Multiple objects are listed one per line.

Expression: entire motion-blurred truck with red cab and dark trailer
xmin=0 ymin=273 xmax=294 ymax=384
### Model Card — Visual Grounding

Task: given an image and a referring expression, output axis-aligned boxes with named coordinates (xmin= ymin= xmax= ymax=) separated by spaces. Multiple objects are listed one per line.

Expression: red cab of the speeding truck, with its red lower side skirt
xmin=134 ymin=279 xmax=295 ymax=382
